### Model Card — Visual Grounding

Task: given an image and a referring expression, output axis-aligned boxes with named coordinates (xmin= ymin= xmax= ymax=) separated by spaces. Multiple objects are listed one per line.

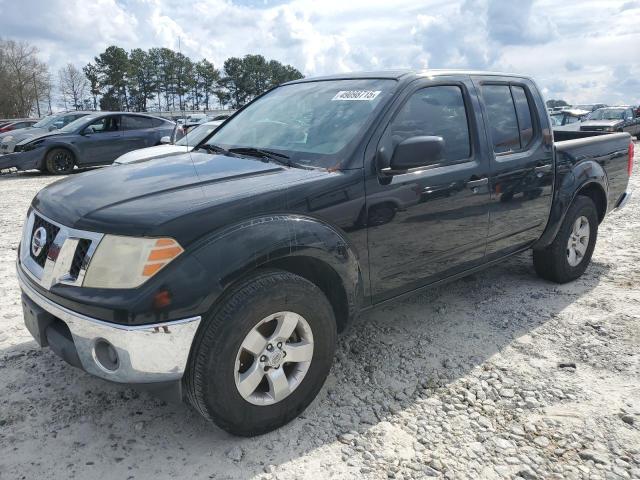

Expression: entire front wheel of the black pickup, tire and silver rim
xmin=185 ymin=270 xmax=337 ymax=436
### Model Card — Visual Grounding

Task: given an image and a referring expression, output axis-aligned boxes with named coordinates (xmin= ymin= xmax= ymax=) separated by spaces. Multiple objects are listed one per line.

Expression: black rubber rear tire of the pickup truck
xmin=533 ymin=195 xmax=598 ymax=283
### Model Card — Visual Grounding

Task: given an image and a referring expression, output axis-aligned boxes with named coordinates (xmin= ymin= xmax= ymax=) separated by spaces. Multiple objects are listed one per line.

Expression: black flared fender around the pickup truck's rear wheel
xmin=533 ymin=151 xmax=609 ymax=248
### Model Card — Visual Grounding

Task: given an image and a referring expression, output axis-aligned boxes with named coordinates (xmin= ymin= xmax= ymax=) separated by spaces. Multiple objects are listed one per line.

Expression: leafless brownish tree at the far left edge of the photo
xmin=0 ymin=40 xmax=49 ymax=117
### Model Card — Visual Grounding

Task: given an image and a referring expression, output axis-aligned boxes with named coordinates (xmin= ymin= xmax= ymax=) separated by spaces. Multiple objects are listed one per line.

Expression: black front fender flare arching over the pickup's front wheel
xmin=192 ymin=214 xmax=362 ymax=313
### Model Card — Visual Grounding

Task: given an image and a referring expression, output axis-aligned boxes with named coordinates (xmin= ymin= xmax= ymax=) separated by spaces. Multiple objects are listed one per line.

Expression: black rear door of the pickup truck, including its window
xmin=473 ymin=77 xmax=554 ymax=261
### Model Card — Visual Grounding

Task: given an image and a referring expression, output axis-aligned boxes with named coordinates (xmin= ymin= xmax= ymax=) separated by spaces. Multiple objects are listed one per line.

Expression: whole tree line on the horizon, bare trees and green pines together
xmin=0 ymin=39 xmax=303 ymax=118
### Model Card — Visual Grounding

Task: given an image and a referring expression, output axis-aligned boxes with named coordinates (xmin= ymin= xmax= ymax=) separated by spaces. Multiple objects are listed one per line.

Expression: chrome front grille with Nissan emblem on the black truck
xmin=19 ymin=208 xmax=104 ymax=290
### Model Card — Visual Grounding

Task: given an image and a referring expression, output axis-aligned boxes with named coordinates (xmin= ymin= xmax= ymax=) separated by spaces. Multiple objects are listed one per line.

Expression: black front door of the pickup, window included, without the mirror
xmin=363 ymin=76 xmax=490 ymax=302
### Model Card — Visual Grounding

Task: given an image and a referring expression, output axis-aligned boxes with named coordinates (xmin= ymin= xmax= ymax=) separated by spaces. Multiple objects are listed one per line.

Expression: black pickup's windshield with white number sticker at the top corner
xmin=207 ymin=79 xmax=396 ymax=167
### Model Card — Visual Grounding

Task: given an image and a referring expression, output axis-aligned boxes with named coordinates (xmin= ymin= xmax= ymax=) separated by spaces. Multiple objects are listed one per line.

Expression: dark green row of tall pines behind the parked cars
xmin=79 ymin=45 xmax=302 ymax=111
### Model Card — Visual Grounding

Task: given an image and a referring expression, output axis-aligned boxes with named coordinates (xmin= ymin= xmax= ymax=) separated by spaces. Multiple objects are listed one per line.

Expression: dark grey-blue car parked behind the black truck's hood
xmin=0 ymin=112 xmax=175 ymax=174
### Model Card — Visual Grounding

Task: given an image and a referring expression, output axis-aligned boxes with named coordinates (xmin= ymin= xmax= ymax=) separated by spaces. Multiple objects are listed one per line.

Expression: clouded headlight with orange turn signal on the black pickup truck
xmin=82 ymin=235 xmax=184 ymax=288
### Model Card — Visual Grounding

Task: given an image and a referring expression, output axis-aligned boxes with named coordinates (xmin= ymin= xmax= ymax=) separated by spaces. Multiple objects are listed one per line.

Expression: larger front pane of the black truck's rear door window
xmin=482 ymin=85 xmax=520 ymax=153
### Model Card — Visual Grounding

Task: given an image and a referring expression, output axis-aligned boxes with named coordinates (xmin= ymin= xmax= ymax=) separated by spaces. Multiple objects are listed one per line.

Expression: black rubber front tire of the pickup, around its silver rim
xmin=184 ymin=270 xmax=337 ymax=436
